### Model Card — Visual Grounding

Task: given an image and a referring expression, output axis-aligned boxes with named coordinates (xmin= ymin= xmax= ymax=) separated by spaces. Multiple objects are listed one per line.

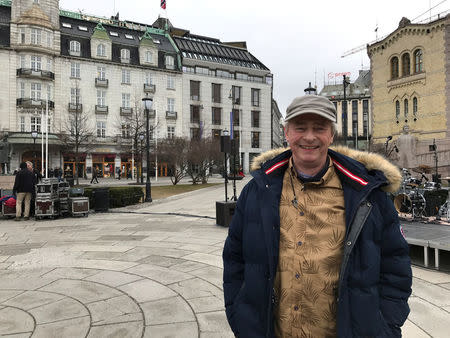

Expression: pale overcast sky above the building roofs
xmin=60 ymin=0 xmax=450 ymax=115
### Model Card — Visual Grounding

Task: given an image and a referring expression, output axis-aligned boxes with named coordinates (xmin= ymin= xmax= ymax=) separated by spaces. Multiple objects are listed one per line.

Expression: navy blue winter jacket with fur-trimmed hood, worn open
xmin=223 ymin=148 xmax=412 ymax=338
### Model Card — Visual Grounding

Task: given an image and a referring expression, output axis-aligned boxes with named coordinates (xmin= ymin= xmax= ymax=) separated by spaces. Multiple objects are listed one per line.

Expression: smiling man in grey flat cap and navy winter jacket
xmin=223 ymin=95 xmax=412 ymax=338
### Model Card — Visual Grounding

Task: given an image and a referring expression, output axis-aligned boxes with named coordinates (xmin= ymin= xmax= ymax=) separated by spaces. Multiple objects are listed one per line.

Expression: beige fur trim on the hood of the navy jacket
xmin=250 ymin=146 xmax=402 ymax=193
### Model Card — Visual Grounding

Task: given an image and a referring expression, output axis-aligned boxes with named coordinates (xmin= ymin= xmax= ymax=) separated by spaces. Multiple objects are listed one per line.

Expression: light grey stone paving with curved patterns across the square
xmin=0 ymin=178 xmax=450 ymax=338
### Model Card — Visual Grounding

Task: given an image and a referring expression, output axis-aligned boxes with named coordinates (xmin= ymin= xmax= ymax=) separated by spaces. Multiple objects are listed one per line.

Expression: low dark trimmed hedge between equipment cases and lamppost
xmin=84 ymin=187 xmax=144 ymax=209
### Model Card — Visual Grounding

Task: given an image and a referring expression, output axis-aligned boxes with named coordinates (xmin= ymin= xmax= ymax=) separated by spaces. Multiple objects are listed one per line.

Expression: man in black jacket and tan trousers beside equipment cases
xmin=13 ymin=162 xmax=36 ymax=221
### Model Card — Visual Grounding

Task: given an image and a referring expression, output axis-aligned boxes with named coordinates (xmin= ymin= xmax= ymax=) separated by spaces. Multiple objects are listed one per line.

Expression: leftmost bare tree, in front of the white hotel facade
xmin=58 ymin=83 xmax=95 ymax=185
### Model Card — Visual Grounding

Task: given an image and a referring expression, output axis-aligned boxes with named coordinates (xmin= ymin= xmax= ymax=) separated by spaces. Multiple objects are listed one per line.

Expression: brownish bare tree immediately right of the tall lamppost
xmin=158 ymin=137 xmax=189 ymax=185
